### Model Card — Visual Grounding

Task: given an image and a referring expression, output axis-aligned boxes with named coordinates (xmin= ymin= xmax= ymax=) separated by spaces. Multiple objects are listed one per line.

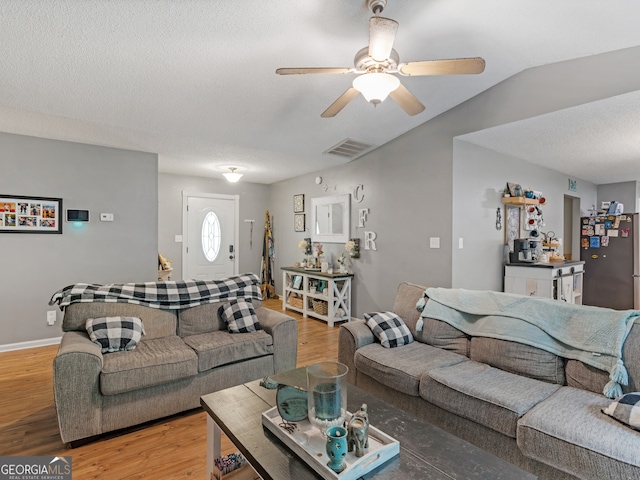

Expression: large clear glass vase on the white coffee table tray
xmin=307 ymin=362 xmax=349 ymax=435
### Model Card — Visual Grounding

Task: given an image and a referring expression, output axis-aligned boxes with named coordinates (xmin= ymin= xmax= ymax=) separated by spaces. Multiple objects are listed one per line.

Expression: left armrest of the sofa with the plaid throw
xmin=53 ymin=332 xmax=102 ymax=443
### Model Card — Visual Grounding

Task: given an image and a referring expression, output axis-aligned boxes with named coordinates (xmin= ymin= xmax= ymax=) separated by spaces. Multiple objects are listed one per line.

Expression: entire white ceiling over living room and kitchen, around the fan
xmin=0 ymin=0 xmax=640 ymax=184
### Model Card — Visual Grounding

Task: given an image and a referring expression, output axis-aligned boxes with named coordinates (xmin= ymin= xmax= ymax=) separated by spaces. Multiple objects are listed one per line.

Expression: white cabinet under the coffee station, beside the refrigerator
xmin=504 ymin=262 xmax=584 ymax=305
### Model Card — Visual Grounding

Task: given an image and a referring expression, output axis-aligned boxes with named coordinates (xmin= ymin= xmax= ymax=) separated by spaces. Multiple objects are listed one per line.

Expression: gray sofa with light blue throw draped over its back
xmin=338 ymin=283 xmax=640 ymax=480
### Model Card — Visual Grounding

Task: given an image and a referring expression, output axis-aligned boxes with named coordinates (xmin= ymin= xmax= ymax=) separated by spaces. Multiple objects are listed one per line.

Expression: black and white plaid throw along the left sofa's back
xmin=49 ymin=273 xmax=262 ymax=310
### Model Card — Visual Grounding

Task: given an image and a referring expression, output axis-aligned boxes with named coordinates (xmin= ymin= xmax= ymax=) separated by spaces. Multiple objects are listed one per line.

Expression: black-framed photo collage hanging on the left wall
xmin=0 ymin=195 xmax=62 ymax=234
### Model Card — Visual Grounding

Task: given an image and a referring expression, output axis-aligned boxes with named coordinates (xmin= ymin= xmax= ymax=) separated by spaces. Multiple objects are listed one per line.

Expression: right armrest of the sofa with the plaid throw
xmin=256 ymin=307 xmax=298 ymax=373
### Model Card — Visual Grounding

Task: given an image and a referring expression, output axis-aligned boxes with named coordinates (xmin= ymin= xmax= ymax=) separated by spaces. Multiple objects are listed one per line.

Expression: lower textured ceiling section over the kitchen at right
xmin=459 ymin=92 xmax=640 ymax=184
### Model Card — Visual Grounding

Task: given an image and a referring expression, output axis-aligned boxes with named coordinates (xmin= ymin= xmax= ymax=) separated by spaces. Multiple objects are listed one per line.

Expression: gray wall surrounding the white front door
xmin=158 ymin=173 xmax=269 ymax=280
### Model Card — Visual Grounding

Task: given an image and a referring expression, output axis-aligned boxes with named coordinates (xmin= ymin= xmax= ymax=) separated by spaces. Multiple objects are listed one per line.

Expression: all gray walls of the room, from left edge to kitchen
xmin=5 ymin=47 xmax=640 ymax=345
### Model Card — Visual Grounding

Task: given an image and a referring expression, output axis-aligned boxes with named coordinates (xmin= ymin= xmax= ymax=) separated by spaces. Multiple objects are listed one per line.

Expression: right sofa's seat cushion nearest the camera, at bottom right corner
xmin=517 ymin=387 xmax=640 ymax=479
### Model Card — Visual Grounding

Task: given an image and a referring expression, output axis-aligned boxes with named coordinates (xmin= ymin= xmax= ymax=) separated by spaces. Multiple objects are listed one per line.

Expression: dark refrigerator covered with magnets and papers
xmin=580 ymin=213 xmax=640 ymax=310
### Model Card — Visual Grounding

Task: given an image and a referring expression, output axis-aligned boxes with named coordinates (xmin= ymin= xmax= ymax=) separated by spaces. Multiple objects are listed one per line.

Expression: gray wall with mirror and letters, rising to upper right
xmin=271 ymin=47 xmax=640 ymax=315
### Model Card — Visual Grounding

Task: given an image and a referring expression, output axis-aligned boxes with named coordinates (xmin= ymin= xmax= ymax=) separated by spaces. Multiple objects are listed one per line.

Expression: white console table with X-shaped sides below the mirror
xmin=282 ymin=267 xmax=353 ymax=327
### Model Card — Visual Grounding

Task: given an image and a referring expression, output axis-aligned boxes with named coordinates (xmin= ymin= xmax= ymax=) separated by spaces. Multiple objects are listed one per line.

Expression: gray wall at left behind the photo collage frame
xmin=0 ymin=133 xmax=158 ymax=349
